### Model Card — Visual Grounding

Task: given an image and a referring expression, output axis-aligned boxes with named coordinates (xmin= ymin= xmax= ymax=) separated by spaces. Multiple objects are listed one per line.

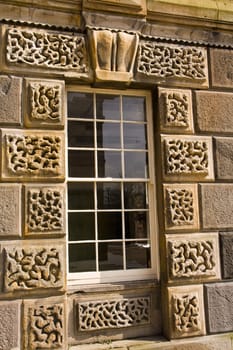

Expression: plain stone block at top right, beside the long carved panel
xmin=210 ymin=49 xmax=233 ymax=88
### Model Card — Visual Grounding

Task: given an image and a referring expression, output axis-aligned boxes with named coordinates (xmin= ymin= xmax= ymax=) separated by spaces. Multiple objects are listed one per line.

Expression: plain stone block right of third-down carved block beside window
xmin=200 ymin=184 xmax=233 ymax=229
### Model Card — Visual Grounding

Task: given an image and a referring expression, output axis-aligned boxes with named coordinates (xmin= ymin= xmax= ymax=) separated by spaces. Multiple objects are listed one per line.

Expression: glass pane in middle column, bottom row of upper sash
xmin=98 ymin=151 xmax=122 ymax=178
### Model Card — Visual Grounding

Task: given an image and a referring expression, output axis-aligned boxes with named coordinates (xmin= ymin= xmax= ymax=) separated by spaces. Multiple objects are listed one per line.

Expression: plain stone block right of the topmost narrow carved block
xmin=195 ymin=91 xmax=233 ymax=133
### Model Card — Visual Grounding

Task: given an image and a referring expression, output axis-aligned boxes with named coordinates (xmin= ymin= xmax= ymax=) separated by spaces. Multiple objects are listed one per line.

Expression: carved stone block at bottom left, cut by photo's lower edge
xmin=23 ymin=298 xmax=65 ymax=350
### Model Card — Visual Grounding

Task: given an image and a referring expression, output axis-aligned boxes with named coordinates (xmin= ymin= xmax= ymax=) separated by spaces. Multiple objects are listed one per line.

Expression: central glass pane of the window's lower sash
xmin=98 ymin=212 xmax=122 ymax=239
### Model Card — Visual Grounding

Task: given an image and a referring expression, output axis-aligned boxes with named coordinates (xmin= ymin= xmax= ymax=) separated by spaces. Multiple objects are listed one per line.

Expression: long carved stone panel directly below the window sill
xmin=77 ymin=297 xmax=150 ymax=331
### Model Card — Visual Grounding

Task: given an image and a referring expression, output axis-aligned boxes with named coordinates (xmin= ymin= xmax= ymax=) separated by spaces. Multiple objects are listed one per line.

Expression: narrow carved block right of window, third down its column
xmin=164 ymin=184 xmax=199 ymax=232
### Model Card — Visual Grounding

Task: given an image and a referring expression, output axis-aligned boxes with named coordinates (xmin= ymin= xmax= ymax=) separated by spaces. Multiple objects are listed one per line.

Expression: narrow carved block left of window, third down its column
xmin=25 ymin=185 xmax=65 ymax=235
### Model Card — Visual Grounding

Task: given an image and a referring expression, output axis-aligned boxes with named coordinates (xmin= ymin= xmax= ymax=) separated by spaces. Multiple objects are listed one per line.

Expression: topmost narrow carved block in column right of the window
xmin=158 ymin=88 xmax=193 ymax=134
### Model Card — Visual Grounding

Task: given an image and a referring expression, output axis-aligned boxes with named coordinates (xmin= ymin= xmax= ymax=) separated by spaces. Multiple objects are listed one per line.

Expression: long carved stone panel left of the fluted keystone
xmin=6 ymin=28 xmax=88 ymax=73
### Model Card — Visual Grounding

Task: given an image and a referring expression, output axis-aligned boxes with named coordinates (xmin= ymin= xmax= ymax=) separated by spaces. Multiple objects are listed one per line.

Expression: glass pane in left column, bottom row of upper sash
xmin=68 ymin=150 xmax=95 ymax=177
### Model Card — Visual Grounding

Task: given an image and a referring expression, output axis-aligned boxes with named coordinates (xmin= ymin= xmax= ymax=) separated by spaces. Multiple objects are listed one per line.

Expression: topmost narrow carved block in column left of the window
xmin=24 ymin=79 xmax=65 ymax=128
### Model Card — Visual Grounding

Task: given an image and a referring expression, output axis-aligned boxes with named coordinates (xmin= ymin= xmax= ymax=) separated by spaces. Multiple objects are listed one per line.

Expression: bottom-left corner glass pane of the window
xmin=69 ymin=243 xmax=96 ymax=272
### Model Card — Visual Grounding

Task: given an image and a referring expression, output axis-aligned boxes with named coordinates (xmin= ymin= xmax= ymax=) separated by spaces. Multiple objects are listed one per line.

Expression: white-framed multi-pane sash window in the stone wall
xmin=67 ymin=88 xmax=157 ymax=283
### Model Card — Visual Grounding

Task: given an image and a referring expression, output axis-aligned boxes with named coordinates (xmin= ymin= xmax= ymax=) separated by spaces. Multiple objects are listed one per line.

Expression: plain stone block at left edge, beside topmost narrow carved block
xmin=0 ymin=75 xmax=22 ymax=125
